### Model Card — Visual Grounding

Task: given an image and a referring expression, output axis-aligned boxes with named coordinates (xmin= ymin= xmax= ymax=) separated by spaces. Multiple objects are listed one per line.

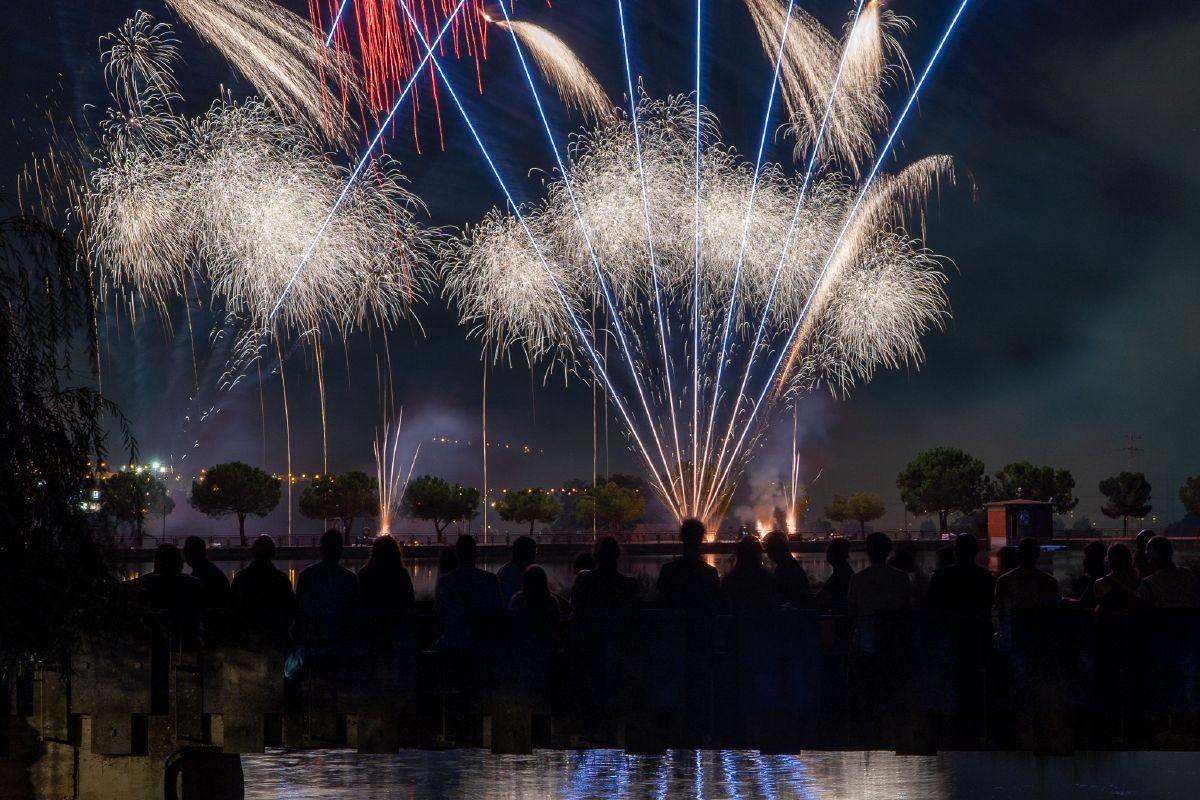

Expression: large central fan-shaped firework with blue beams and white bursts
xmin=434 ymin=2 xmax=961 ymax=534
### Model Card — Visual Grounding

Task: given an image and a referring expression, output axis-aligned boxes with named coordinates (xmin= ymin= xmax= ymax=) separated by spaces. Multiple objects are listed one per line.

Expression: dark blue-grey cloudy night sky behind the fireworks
xmin=0 ymin=0 xmax=1200 ymax=531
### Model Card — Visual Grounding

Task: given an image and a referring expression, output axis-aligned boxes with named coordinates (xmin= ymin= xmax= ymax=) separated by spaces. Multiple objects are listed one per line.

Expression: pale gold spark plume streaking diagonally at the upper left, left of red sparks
xmin=166 ymin=0 xmax=359 ymax=142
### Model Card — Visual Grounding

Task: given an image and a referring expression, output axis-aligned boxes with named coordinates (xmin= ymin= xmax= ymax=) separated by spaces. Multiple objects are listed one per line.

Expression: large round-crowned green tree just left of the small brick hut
xmin=896 ymin=447 xmax=990 ymax=534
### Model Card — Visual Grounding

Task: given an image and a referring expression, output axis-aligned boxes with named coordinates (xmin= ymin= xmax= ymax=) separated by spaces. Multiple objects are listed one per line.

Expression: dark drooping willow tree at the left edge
xmin=0 ymin=216 xmax=137 ymax=672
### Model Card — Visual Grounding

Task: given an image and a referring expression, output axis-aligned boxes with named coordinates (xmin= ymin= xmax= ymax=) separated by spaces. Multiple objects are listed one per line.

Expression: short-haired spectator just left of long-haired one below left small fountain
xmin=296 ymin=530 xmax=359 ymax=646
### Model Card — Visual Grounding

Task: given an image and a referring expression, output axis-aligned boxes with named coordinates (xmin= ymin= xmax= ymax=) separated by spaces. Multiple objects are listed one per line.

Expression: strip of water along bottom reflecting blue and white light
xmin=242 ymin=750 xmax=1200 ymax=800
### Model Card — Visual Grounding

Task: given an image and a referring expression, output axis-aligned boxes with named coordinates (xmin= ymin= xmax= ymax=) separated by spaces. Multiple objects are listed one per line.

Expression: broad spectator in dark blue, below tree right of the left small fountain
xmin=434 ymin=535 xmax=503 ymax=652
